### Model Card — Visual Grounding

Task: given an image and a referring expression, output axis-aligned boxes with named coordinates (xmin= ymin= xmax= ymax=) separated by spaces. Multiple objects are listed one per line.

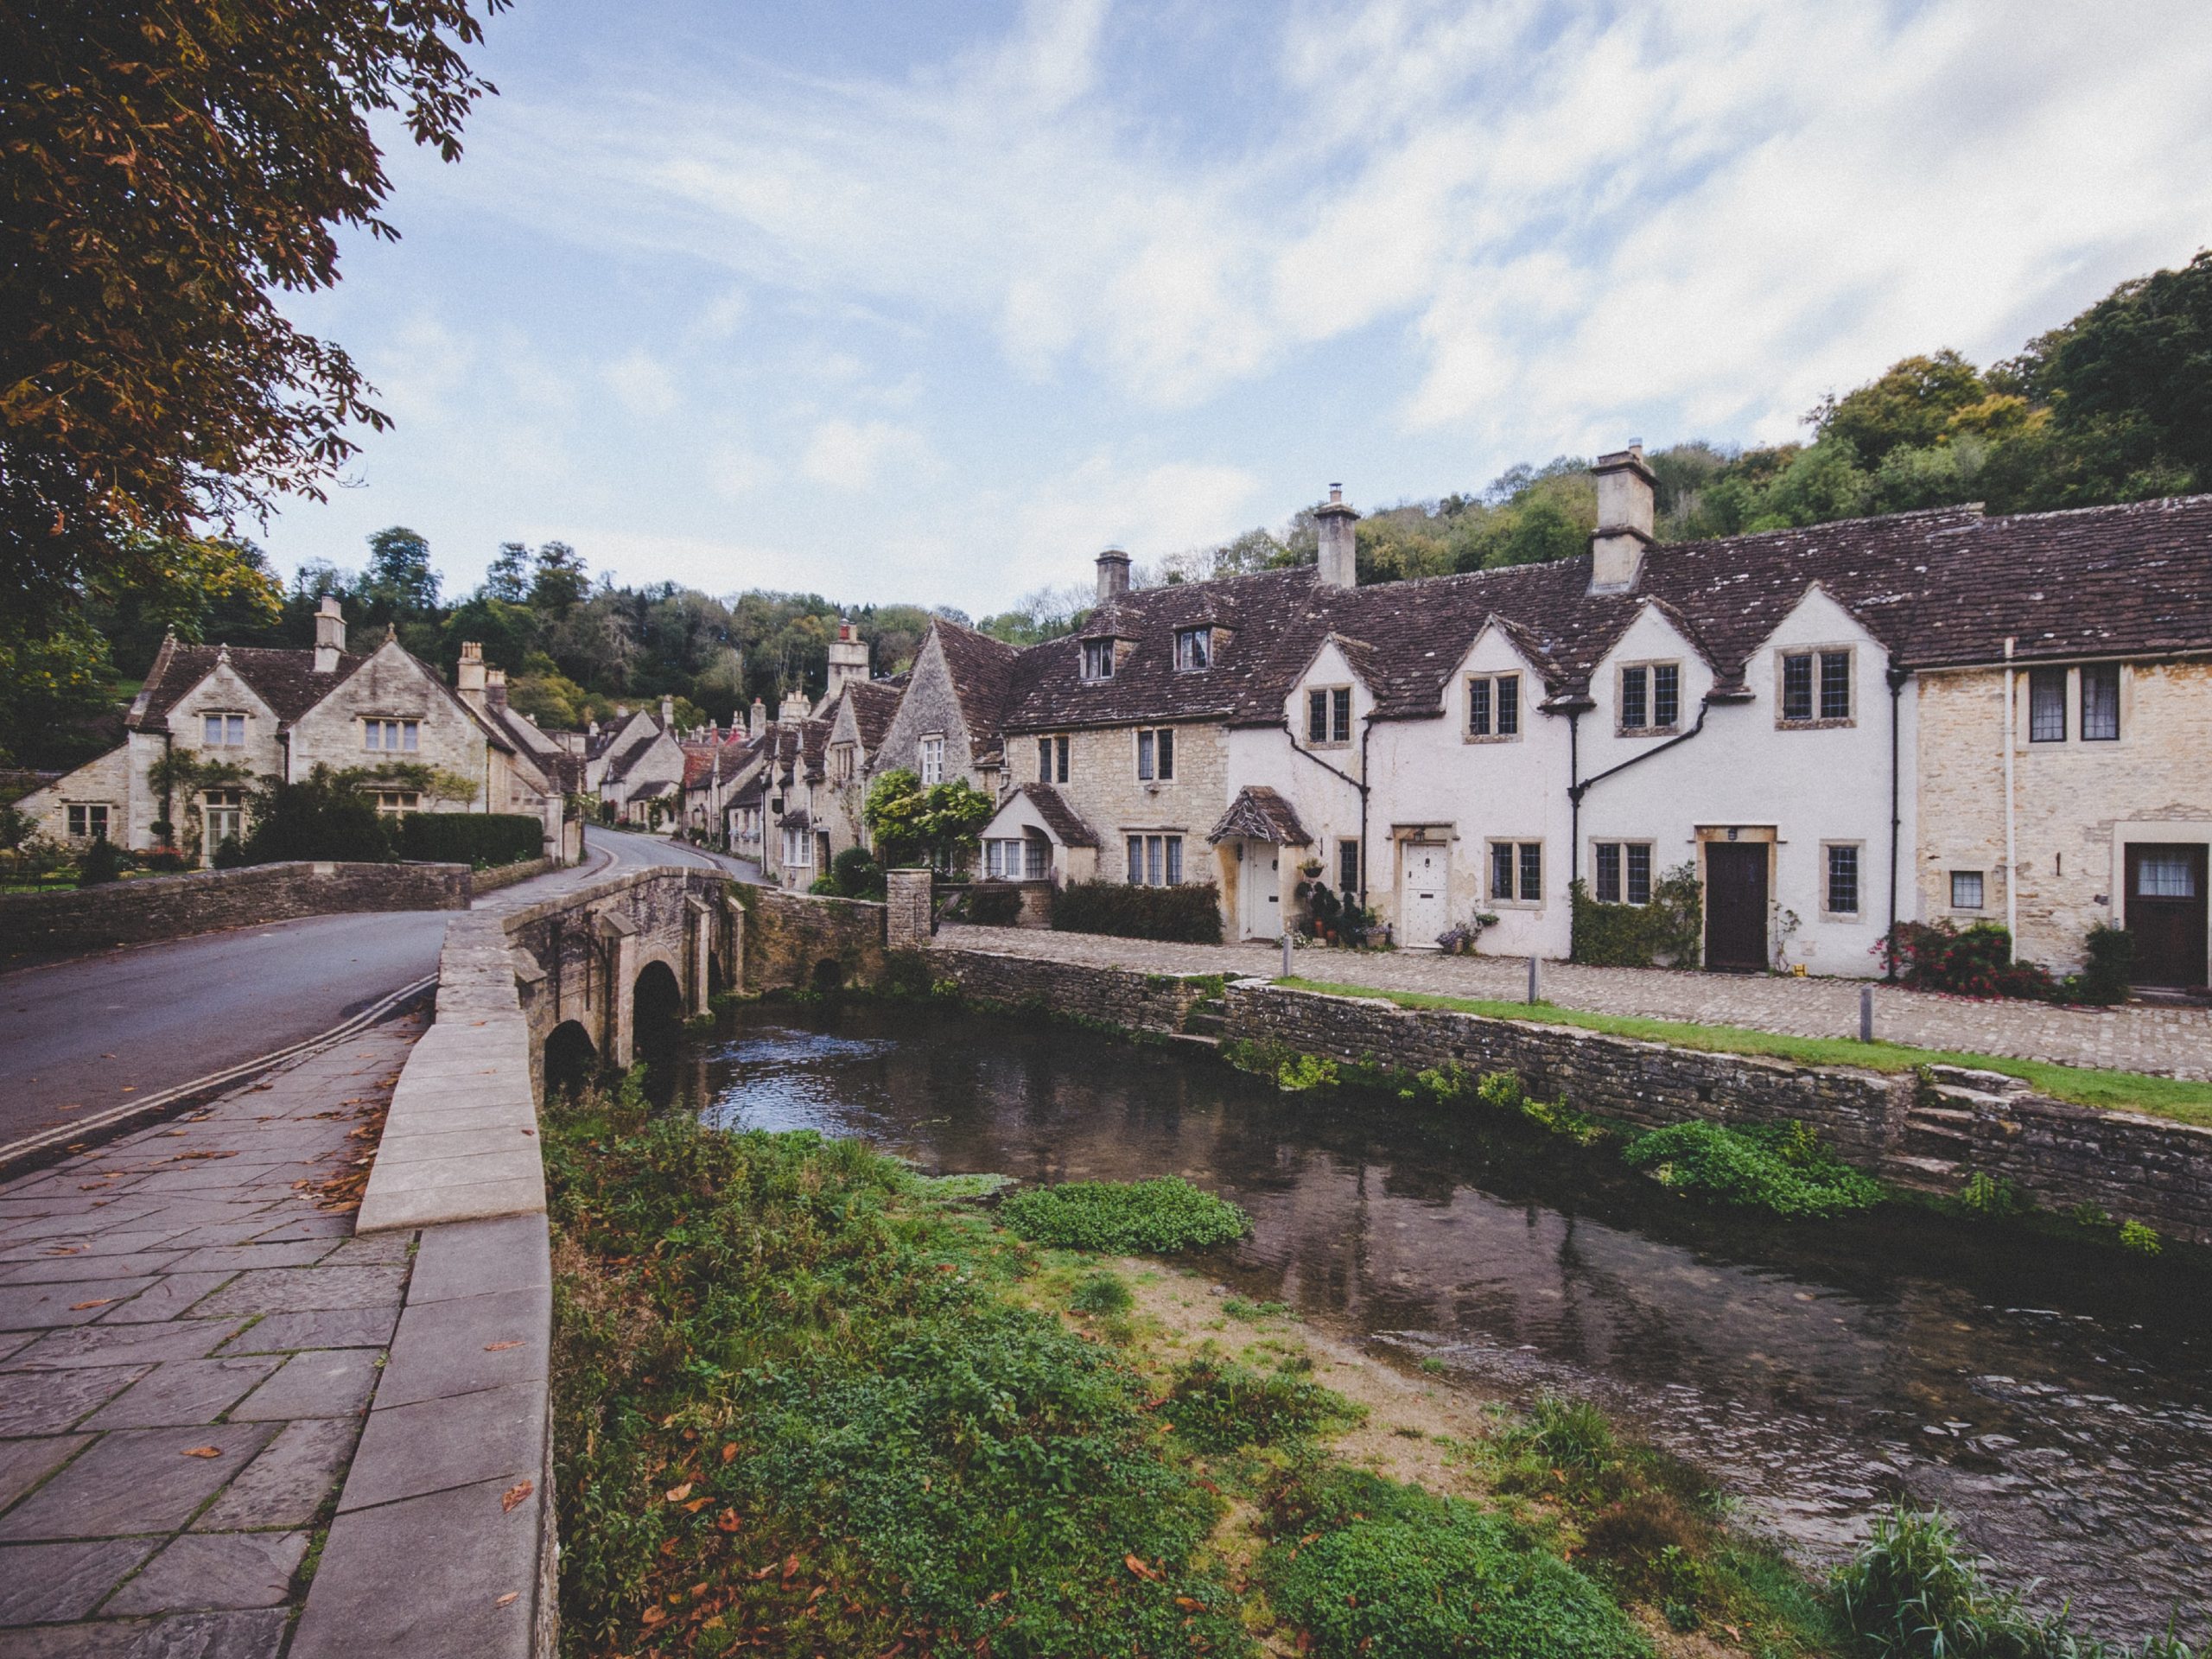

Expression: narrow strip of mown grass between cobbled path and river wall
xmin=1276 ymin=978 xmax=2212 ymax=1128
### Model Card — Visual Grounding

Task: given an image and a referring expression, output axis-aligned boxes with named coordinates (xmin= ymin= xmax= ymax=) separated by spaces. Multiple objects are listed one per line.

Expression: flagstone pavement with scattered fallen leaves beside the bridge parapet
xmin=0 ymin=1018 xmax=423 ymax=1659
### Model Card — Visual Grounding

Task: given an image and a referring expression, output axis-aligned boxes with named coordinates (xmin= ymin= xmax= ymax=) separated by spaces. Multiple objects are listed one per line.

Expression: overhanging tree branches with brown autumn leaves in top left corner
xmin=0 ymin=0 xmax=505 ymax=635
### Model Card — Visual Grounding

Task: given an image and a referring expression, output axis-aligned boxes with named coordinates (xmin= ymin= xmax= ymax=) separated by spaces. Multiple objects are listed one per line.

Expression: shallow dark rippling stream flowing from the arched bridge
xmin=655 ymin=1004 xmax=2212 ymax=1637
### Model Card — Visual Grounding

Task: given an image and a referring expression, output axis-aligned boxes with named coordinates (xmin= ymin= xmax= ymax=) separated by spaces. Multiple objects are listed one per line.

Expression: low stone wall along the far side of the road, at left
xmin=0 ymin=862 xmax=474 ymax=957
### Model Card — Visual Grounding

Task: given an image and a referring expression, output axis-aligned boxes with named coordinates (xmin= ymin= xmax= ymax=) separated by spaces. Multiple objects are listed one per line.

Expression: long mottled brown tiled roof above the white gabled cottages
xmin=1004 ymin=495 xmax=2212 ymax=732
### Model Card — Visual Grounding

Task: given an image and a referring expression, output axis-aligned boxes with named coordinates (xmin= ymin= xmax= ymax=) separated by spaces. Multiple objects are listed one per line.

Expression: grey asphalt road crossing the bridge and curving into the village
xmin=0 ymin=830 xmax=739 ymax=1146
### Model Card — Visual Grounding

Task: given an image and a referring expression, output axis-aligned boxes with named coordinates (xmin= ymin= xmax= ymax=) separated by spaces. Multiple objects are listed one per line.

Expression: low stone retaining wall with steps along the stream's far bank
xmin=929 ymin=949 xmax=2212 ymax=1245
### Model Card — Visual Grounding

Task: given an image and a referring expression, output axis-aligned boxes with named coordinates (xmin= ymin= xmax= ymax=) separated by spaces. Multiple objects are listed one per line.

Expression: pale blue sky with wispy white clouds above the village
xmin=267 ymin=0 xmax=2212 ymax=615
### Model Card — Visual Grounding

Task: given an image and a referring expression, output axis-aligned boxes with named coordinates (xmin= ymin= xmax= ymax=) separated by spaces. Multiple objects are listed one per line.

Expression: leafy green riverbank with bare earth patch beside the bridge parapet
xmin=546 ymin=1079 xmax=1838 ymax=1659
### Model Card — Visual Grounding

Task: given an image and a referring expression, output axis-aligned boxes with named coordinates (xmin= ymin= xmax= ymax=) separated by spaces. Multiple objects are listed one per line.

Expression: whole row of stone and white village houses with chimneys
xmin=24 ymin=445 xmax=2212 ymax=987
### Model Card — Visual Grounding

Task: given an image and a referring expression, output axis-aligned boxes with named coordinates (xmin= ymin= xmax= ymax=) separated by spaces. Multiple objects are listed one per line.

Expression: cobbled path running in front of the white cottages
xmin=938 ymin=927 xmax=2212 ymax=1079
